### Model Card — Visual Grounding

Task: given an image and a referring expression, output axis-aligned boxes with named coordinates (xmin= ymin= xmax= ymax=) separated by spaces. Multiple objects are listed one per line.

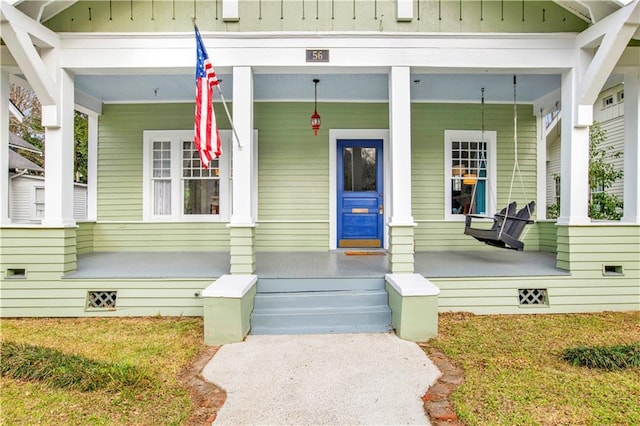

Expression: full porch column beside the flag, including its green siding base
xmin=223 ymin=67 xmax=257 ymax=274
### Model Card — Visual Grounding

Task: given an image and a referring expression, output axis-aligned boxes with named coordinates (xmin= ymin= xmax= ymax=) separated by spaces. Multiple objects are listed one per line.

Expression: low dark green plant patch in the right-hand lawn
xmin=561 ymin=342 xmax=640 ymax=370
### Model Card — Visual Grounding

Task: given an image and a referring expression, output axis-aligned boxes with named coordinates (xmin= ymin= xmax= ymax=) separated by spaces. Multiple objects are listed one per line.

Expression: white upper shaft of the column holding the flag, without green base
xmin=231 ymin=67 xmax=257 ymax=226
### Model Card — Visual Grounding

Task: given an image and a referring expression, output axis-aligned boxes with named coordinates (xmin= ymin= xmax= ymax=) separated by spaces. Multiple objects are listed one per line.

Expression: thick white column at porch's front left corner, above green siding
xmin=42 ymin=69 xmax=75 ymax=226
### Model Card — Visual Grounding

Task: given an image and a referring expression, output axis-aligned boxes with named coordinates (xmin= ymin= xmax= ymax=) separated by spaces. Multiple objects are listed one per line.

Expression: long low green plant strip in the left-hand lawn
xmin=0 ymin=341 xmax=151 ymax=391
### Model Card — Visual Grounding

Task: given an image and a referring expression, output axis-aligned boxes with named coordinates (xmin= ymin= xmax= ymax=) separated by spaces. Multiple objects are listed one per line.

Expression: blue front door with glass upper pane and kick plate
xmin=337 ymin=139 xmax=384 ymax=247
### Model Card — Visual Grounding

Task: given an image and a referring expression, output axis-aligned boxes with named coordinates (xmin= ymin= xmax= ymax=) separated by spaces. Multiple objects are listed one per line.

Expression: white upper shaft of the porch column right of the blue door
xmin=389 ymin=67 xmax=415 ymax=226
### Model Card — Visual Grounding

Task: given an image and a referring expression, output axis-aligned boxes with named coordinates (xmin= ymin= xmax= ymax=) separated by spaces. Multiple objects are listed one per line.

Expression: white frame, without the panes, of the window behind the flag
xmin=142 ymin=130 xmax=232 ymax=222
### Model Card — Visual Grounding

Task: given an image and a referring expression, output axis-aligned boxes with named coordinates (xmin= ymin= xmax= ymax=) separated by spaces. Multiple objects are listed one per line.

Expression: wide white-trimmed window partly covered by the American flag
xmin=143 ymin=130 xmax=231 ymax=221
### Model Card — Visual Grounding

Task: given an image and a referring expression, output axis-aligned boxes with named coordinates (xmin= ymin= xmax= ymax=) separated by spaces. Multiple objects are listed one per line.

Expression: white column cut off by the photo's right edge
xmin=622 ymin=70 xmax=640 ymax=223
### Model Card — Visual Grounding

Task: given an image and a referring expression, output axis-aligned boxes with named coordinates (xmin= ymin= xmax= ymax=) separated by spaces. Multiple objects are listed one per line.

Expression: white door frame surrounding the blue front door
xmin=329 ymin=129 xmax=391 ymax=250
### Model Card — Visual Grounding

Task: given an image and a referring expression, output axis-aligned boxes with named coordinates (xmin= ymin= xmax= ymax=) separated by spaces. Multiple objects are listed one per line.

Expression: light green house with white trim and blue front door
xmin=0 ymin=0 xmax=640 ymax=343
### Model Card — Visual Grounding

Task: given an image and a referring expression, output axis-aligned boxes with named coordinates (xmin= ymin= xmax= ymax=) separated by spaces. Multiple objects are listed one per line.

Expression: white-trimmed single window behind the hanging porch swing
xmin=444 ymin=130 xmax=497 ymax=220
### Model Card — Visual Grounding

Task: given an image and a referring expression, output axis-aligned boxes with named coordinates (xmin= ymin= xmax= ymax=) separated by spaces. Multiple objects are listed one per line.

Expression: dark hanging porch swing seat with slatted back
xmin=464 ymin=201 xmax=535 ymax=250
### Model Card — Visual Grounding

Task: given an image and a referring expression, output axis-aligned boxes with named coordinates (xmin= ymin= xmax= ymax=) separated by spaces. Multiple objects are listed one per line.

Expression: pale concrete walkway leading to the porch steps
xmin=202 ymin=333 xmax=440 ymax=425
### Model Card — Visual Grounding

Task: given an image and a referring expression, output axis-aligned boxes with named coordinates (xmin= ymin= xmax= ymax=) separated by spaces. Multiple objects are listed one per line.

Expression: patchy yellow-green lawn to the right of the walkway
xmin=429 ymin=312 xmax=640 ymax=425
